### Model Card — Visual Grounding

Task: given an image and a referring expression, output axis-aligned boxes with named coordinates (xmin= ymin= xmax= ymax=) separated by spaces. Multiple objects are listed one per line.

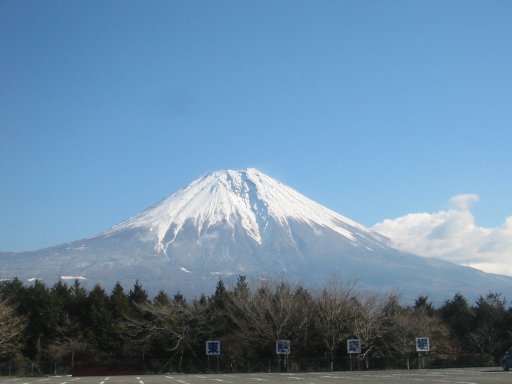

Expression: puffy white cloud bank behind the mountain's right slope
xmin=372 ymin=194 xmax=512 ymax=276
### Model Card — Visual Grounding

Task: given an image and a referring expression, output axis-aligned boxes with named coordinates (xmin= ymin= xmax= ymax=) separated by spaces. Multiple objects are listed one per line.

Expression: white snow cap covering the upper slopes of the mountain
xmin=105 ymin=168 xmax=387 ymax=252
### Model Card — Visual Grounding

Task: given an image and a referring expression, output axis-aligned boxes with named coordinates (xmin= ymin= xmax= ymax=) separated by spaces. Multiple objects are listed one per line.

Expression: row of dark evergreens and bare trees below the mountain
xmin=0 ymin=276 xmax=512 ymax=371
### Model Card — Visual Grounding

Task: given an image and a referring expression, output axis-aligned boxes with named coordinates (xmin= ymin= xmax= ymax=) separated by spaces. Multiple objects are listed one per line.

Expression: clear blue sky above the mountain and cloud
xmin=0 ymin=0 xmax=512 ymax=251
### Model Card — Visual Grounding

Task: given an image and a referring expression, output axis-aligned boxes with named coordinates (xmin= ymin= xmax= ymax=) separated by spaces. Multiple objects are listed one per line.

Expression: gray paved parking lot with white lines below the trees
xmin=0 ymin=368 xmax=512 ymax=384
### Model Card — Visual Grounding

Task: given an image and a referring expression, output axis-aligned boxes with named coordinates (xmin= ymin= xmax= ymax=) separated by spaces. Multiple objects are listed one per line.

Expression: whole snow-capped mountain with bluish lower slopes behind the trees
xmin=0 ymin=169 xmax=512 ymax=300
